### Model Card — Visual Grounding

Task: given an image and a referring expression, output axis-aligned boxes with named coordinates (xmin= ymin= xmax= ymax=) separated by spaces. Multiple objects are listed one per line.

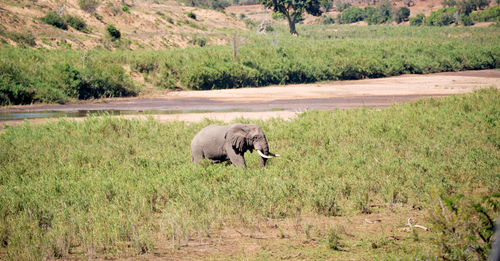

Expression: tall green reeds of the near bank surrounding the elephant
xmin=0 ymin=89 xmax=500 ymax=259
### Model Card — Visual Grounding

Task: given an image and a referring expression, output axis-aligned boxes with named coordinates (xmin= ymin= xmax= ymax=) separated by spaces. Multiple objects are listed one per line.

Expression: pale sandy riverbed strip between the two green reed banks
xmin=0 ymin=70 xmax=500 ymax=127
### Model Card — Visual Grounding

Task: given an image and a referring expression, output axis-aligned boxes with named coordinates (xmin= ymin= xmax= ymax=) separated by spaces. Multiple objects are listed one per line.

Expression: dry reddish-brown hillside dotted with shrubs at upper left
xmin=0 ymin=0 xmax=245 ymax=49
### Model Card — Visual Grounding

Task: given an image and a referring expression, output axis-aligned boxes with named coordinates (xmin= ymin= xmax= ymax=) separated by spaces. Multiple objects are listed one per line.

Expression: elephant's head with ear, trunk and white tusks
xmin=225 ymin=124 xmax=279 ymax=167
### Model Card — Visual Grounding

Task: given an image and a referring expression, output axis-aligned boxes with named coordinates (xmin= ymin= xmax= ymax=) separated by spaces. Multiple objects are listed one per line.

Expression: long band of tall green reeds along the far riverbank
xmin=0 ymin=26 xmax=500 ymax=104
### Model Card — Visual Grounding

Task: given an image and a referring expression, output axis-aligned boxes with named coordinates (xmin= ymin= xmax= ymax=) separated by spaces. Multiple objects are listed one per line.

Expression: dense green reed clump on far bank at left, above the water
xmin=0 ymin=47 xmax=139 ymax=105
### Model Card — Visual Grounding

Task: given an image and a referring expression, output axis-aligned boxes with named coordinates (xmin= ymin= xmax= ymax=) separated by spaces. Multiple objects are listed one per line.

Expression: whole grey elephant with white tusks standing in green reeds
xmin=191 ymin=124 xmax=279 ymax=167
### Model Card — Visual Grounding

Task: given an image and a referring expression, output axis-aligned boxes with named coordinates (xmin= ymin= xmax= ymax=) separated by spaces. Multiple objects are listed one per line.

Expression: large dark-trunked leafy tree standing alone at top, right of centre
xmin=260 ymin=0 xmax=322 ymax=35
